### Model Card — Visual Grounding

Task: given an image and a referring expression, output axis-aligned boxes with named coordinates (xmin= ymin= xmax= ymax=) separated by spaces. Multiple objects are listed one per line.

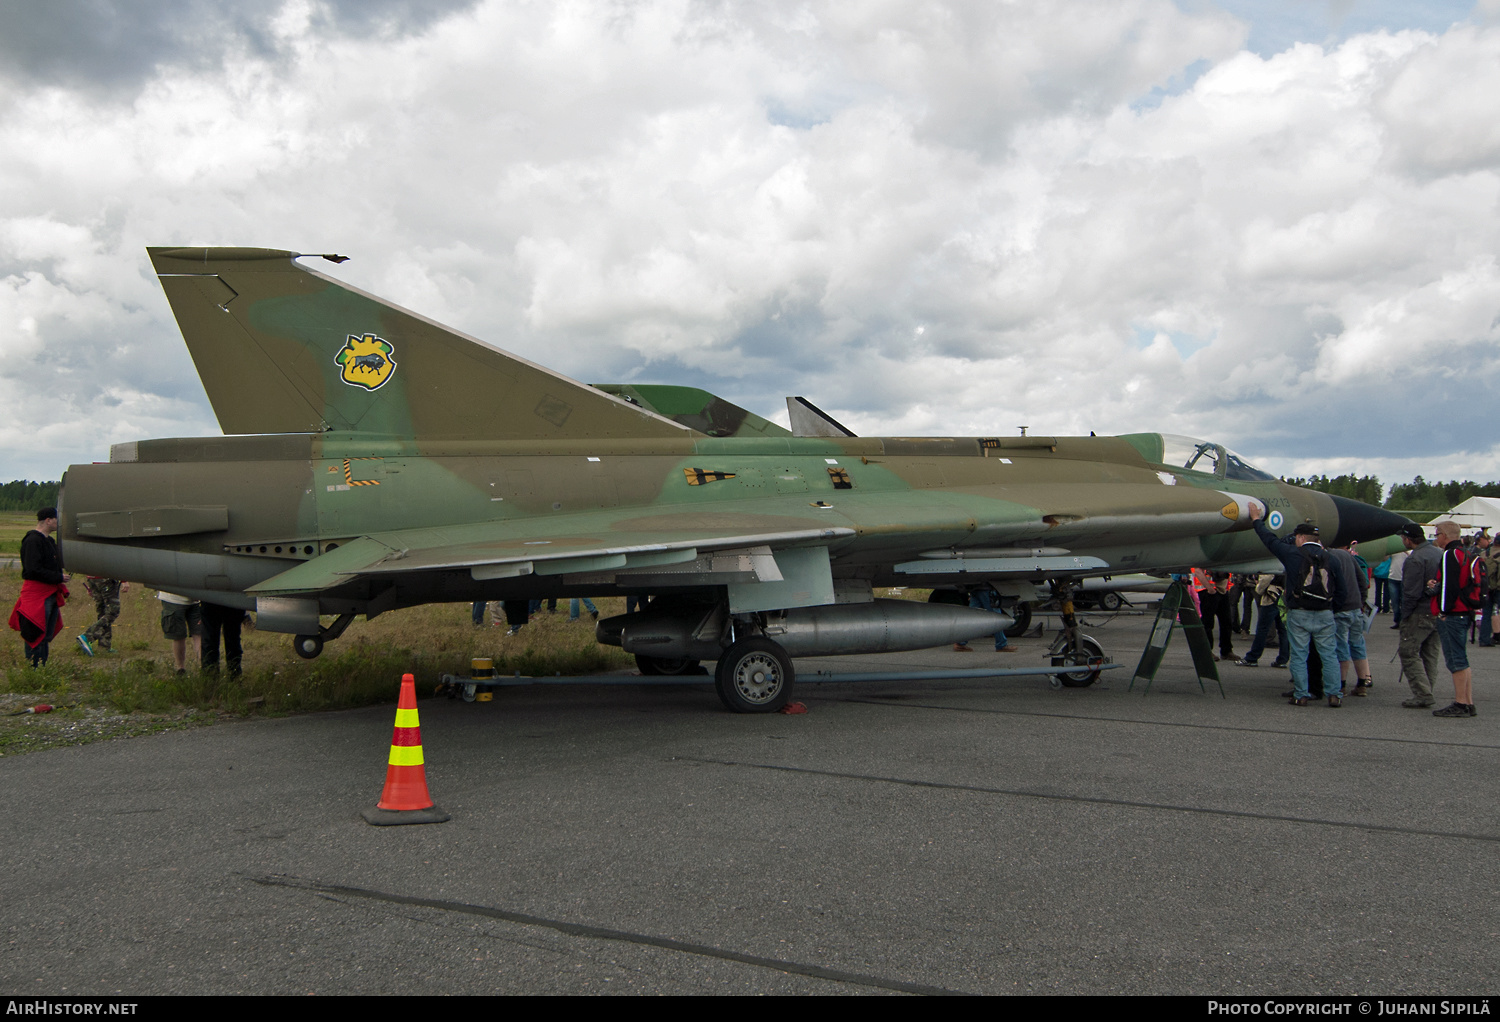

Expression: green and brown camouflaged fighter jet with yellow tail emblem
xmin=59 ymin=248 xmax=1406 ymax=713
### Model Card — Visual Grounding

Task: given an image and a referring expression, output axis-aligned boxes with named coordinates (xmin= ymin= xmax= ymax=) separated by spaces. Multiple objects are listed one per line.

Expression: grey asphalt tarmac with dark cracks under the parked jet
xmin=0 ymin=606 xmax=1500 ymax=995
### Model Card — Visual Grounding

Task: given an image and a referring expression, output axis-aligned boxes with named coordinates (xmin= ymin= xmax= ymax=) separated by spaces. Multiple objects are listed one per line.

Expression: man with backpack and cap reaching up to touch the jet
xmin=1250 ymin=503 xmax=1344 ymax=708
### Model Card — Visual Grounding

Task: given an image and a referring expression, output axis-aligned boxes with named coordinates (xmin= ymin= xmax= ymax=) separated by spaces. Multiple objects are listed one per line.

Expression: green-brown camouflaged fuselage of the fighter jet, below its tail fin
xmin=60 ymin=434 xmax=1374 ymax=627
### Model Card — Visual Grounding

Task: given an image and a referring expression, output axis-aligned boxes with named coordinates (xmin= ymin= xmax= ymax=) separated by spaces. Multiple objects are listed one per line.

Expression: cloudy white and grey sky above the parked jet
xmin=0 ymin=0 xmax=1500 ymax=483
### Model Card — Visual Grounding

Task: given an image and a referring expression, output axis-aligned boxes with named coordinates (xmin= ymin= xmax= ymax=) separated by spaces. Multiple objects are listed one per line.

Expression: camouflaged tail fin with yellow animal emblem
xmin=147 ymin=248 xmax=693 ymax=440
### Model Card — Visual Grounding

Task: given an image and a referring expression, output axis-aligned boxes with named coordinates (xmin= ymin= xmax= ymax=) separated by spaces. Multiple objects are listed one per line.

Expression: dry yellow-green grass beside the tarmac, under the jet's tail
xmin=0 ymin=569 xmax=635 ymax=755
